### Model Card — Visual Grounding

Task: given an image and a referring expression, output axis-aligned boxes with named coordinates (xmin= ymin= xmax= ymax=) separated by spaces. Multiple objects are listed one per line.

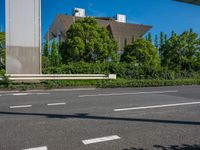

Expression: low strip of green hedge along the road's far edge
xmin=1 ymin=79 xmax=200 ymax=90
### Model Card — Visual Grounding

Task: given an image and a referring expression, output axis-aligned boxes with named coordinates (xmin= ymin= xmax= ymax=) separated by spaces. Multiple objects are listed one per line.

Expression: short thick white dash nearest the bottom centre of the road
xmin=82 ymin=135 xmax=120 ymax=145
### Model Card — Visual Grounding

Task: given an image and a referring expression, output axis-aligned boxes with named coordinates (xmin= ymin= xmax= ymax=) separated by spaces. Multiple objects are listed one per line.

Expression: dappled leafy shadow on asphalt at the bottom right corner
xmin=123 ymin=144 xmax=200 ymax=150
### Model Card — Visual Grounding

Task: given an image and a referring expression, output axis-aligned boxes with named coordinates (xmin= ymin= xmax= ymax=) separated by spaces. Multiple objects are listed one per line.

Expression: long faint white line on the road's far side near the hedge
xmin=79 ymin=91 xmax=178 ymax=98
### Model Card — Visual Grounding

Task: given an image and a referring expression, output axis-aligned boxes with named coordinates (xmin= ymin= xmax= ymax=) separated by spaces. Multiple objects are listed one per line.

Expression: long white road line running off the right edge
xmin=114 ymin=102 xmax=200 ymax=112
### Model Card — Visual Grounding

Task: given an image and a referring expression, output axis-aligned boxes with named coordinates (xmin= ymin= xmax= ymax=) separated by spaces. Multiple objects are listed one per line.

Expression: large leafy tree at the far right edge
xmin=161 ymin=30 xmax=200 ymax=70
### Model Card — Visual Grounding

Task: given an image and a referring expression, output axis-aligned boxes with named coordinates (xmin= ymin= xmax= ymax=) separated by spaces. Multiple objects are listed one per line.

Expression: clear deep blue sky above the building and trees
xmin=0 ymin=0 xmax=200 ymax=40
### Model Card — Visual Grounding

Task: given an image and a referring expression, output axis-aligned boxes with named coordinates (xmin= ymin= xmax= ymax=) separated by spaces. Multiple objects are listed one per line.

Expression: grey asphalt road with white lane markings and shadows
xmin=0 ymin=86 xmax=200 ymax=150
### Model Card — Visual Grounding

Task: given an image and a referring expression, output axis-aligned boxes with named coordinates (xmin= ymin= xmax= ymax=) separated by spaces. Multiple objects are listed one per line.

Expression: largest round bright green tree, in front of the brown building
xmin=61 ymin=17 xmax=117 ymax=63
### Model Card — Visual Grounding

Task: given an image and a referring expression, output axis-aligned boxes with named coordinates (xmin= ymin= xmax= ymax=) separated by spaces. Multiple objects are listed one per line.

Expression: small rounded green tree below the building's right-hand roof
xmin=121 ymin=39 xmax=160 ymax=66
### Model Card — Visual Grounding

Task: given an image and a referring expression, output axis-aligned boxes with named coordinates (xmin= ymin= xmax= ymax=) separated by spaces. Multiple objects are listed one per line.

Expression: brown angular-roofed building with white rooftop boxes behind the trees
xmin=45 ymin=8 xmax=151 ymax=51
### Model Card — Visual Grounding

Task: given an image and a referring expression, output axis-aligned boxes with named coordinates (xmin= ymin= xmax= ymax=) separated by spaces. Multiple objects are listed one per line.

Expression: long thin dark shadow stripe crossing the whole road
xmin=0 ymin=111 xmax=200 ymax=126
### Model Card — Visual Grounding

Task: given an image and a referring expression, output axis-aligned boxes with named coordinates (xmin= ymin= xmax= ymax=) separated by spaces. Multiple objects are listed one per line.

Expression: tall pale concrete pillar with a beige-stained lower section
xmin=6 ymin=0 xmax=41 ymax=74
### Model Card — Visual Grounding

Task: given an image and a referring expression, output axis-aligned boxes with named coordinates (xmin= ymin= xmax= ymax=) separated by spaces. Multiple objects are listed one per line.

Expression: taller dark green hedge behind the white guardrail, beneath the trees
xmin=43 ymin=63 xmax=200 ymax=80
